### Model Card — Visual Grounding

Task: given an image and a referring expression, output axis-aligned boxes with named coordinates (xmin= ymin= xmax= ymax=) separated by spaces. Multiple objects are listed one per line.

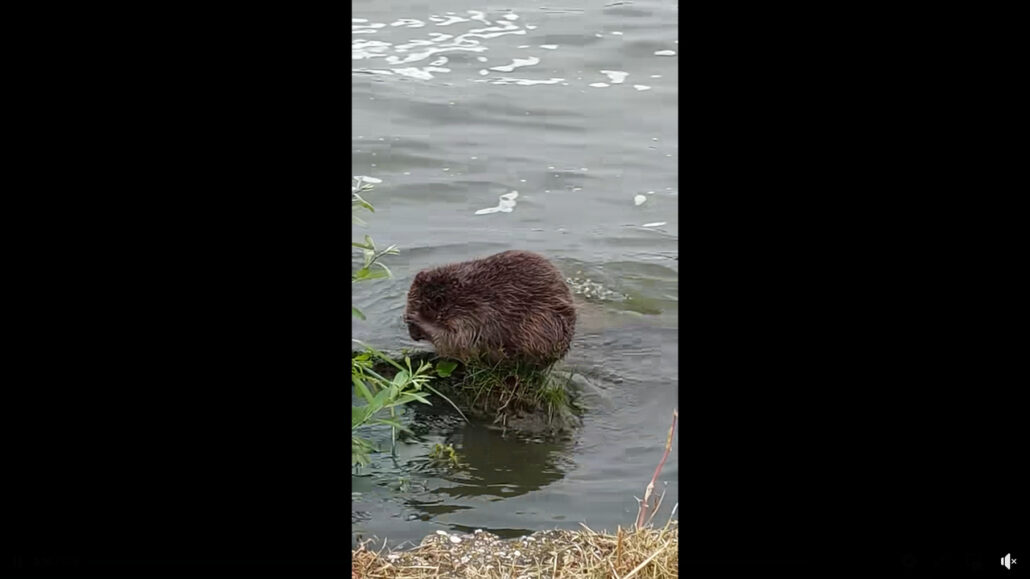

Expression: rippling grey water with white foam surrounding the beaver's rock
xmin=351 ymin=0 xmax=675 ymax=546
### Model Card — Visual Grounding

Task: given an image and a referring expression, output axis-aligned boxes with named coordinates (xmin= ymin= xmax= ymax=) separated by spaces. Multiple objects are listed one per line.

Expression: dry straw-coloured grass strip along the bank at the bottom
xmin=351 ymin=519 xmax=680 ymax=579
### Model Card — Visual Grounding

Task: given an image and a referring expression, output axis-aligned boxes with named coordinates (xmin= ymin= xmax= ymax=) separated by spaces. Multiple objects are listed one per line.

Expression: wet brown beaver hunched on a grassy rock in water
xmin=404 ymin=250 xmax=576 ymax=366
